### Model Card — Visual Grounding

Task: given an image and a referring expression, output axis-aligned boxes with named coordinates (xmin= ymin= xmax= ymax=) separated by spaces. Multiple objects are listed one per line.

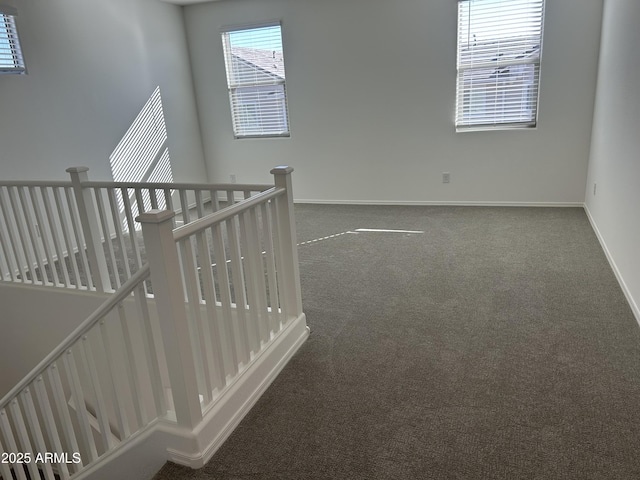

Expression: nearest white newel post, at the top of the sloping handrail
xmin=136 ymin=210 xmax=202 ymax=430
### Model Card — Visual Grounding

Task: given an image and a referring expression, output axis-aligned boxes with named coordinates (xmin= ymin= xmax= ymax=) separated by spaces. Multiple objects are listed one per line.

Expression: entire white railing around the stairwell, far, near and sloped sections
xmin=0 ymin=169 xmax=301 ymax=479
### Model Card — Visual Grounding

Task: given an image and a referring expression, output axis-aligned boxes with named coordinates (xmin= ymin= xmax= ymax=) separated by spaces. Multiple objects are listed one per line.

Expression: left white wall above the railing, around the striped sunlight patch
xmin=0 ymin=0 xmax=206 ymax=181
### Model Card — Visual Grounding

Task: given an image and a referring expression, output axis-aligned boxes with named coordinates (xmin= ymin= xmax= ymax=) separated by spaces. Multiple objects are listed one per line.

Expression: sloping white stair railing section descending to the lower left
xmin=0 ymin=265 xmax=167 ymax=480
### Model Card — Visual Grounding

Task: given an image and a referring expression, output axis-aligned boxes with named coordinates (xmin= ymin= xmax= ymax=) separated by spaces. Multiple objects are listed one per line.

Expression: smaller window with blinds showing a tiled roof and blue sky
xmin=222 ymin=25 xmax=289 ymax=138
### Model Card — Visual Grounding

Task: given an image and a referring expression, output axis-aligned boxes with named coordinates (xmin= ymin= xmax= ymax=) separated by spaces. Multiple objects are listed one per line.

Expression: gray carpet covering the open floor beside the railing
xmin=155 ymin=205 xmax=640 ymax=480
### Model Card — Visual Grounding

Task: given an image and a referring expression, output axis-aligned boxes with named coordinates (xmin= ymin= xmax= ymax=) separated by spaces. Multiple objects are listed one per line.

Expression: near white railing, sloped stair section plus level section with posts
xmin=0 ymin=167 xmax=306 ymax=480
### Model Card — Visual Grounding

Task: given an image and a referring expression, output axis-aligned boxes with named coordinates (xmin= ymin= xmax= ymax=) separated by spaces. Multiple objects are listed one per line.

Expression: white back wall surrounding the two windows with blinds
xmin=185 ymin=0 xmax=602 ymax=203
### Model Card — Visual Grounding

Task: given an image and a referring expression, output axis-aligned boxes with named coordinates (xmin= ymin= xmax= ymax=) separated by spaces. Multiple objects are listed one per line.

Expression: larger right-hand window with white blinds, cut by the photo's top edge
xmin=455 ymin=0 xmax=544 ymax=130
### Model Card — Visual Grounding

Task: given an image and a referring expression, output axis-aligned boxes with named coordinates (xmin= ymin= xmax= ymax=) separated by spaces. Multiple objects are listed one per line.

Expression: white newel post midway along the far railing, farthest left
xmin=66 ymin=167 xmax=111 ymax=292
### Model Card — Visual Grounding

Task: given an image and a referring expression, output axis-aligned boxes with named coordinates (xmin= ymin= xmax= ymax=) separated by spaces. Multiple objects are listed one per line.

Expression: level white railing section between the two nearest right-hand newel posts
xmin=138 ymin=167 xmax=302 ymax=425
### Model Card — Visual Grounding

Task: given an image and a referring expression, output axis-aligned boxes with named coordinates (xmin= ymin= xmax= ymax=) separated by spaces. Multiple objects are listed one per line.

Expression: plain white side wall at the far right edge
xmin=586 ymin=0 xmax=640 ymax=321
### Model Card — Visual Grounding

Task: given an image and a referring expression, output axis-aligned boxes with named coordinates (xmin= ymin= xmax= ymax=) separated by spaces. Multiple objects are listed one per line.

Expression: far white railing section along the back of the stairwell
xmin=0 ymin=167 xmax=269 ymax=292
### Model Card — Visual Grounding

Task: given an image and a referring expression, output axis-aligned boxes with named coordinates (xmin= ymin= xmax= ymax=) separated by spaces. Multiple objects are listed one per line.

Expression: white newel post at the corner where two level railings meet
xmin=271 ymin=166 xmax=302 ymax=317
